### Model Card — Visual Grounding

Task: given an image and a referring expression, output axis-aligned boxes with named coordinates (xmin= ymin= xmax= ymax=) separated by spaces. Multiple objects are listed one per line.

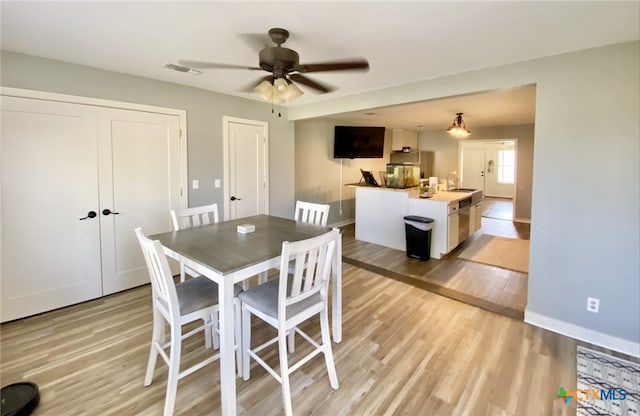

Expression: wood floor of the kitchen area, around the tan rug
xmin=342 ymin=217 xmax=530 ymax=320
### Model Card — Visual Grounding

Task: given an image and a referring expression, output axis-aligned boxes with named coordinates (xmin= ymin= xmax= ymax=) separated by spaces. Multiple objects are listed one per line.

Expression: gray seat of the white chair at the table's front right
xmin=238 ymin=276 xmax=322 ymax=319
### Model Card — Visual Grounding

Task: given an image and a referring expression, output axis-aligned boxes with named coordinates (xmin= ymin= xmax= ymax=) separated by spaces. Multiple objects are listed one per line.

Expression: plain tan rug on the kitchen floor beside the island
xmin=458 ymin=234 xmax=529 ymax=273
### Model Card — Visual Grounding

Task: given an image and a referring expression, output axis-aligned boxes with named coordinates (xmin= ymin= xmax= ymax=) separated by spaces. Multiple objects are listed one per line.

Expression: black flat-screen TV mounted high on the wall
xmin=333 ymin=126 xmax=384 ymax=159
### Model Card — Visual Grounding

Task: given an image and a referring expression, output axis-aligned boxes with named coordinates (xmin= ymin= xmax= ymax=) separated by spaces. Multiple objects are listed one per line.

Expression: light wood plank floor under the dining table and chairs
xmin=0 ymin=264 xmax=636 ymax=416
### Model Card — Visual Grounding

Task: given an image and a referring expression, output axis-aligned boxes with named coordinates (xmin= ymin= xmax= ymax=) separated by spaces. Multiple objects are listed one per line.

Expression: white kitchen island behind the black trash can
xmin=349 ymin=185 xmax=482 ymax=259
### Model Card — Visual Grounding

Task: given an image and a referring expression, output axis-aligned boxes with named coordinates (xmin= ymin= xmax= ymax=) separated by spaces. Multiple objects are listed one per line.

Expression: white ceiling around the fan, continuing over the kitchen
xmin=0 ymin=0 xmax=640 ymax=129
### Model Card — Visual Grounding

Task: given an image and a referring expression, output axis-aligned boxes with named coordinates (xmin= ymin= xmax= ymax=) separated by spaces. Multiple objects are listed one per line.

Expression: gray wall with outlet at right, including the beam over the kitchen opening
xmin=289 ymin=41 xmax=640 ymax=348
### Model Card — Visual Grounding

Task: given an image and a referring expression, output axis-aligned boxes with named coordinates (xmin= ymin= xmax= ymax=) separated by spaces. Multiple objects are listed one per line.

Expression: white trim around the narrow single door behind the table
xmin=222 ymin=116 xmax=269 ymax=220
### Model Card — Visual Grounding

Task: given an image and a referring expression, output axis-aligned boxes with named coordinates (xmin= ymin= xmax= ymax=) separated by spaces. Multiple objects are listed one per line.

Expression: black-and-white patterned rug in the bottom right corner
xmin=576 ymin=346 xmax=640 ymax=416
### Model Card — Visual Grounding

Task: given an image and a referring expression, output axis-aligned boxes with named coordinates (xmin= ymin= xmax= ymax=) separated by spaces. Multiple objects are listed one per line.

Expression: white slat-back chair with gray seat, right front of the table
xmin=239 ymin=229 xmax=338 ymax=416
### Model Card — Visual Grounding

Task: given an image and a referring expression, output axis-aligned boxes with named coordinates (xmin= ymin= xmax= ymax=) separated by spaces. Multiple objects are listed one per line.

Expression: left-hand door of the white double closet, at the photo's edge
xmin=0 ymin=97 xmax=102 ymax=322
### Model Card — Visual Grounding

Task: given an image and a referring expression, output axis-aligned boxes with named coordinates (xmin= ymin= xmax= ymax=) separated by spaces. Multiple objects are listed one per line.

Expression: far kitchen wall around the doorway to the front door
xmin=418 ymin=124 xmax=535 ymax=220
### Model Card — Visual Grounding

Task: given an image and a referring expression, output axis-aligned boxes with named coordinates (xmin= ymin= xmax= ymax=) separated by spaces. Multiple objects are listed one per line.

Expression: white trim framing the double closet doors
xmin=0 ymin=87 xmax=189 ymax=208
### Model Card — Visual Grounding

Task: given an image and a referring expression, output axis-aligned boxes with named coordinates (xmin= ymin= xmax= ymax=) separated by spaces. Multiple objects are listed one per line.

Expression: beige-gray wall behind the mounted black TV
xmin=295 ymin=119 xmax=393 ymax=224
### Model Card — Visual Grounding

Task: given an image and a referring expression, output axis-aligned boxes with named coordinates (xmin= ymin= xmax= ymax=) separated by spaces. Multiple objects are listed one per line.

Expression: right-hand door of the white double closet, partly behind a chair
xmin=98 ymin=109 xmax=181 ymax=295
